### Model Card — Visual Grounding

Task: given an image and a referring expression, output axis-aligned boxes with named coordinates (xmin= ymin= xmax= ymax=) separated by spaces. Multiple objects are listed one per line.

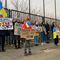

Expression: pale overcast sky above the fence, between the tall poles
xmin=1 ymin=0 xmax=60 ymax=18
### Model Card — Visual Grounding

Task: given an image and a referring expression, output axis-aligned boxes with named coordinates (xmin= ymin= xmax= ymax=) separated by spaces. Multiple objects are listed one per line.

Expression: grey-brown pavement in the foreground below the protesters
xmin=0 ymin=43 xmax=60 ymax=60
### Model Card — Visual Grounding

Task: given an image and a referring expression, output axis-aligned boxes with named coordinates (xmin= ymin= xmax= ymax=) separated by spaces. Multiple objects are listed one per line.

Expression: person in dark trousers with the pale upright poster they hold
xmin=14 ymin=22 xmax=21 ymax=49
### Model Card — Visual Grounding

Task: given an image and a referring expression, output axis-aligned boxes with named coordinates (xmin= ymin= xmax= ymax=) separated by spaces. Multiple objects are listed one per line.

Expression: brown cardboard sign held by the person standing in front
xmin=20 ymin=29 xmax=36 ymax=40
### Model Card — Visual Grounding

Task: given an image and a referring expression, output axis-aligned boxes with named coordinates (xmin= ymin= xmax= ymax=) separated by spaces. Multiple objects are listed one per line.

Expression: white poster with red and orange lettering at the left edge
xmin=0 ymin=18 xmax=13 ymax=30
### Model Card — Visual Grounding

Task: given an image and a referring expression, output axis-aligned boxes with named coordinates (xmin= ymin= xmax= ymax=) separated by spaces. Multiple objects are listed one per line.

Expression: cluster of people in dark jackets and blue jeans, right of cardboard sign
xmin=34 ymin=22 xmax=55 ymax=43
